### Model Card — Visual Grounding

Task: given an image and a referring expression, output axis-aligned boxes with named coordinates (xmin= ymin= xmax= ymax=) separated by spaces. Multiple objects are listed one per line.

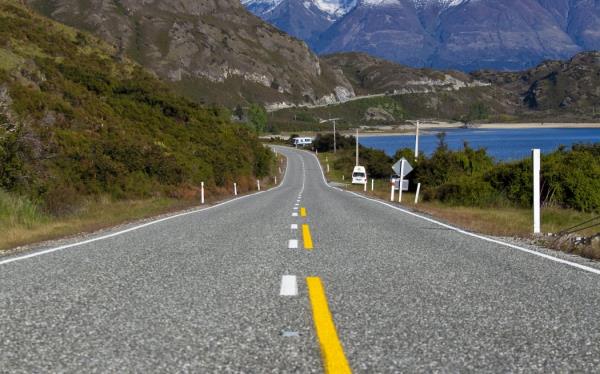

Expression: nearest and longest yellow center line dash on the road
xmin=306 ymin=277 xmax=352 ymax=374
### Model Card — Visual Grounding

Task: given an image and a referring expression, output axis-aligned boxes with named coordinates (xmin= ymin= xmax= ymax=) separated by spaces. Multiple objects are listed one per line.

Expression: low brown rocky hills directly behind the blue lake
xmin=270 ymin=52 xmax=600 ymax=131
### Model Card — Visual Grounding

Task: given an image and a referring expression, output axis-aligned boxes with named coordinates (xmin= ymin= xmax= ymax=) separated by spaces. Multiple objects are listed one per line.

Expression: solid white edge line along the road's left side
xmin=0 ymin=149 xmax=290 ymax=265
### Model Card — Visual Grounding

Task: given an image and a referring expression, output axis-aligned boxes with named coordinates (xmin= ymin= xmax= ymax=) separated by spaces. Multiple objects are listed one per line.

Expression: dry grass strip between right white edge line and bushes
xmin=318 ymin=153 xmax=596 ymax=237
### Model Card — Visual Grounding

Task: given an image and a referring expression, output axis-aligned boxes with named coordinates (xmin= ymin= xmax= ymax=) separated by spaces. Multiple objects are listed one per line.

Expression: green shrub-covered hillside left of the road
xmin=0 ymin=1 xmax=273 ymax=215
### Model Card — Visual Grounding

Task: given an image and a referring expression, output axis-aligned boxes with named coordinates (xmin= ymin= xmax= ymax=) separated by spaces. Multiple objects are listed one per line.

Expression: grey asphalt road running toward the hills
xmin=0 ymin=149 xmax=600 ymax=373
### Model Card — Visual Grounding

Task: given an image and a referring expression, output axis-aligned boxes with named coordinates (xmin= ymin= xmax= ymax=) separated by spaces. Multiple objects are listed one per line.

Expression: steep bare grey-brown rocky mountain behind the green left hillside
xmin=28 ymin=0 xmax=352 ymax=105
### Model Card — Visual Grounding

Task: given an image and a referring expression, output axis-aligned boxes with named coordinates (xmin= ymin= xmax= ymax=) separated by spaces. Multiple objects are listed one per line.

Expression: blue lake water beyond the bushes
xmin=359 ymin=128 xmax=600 ymax=161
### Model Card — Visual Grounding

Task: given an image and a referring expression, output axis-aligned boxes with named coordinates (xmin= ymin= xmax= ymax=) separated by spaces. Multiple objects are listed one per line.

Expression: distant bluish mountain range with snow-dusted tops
xmin=244 ymin=0 xmax=600 ymax=71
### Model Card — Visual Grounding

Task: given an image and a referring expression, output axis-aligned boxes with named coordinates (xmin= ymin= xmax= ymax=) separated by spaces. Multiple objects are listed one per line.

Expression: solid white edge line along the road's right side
xmin=304 ymin=151 xmax=600 ymax=275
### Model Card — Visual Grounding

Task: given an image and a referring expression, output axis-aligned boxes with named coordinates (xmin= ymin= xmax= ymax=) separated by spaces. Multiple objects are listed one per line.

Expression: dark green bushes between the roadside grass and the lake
xmin=315 ymin=133 xmax=600 ymax=212
